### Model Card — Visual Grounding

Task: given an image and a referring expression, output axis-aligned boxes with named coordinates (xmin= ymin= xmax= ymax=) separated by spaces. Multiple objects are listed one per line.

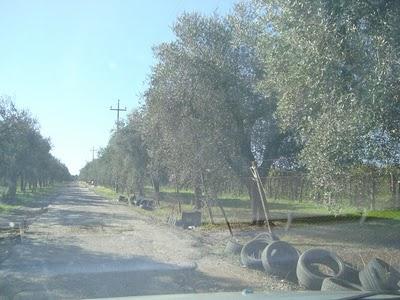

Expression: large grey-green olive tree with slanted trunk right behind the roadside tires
xmin=146 ymin=14 xmax=294 ymax=222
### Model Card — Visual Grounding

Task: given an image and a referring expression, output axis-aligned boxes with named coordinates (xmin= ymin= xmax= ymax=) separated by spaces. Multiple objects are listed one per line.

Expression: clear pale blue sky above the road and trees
xmin=0 ymin=0 xmax=237 ymax=174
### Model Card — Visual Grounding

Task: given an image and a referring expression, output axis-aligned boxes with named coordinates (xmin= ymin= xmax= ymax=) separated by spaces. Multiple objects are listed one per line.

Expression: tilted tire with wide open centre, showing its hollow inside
xmin=296 ymin=248 xmax=345 ymax=290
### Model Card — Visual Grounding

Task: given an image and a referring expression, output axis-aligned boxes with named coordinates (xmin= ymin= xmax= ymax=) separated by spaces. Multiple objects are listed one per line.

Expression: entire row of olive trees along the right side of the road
xmin=80 ymin=0 xmax=400 ymax=222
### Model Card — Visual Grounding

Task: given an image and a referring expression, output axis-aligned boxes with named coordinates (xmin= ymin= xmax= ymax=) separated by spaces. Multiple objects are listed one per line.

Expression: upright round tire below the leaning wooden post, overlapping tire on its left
xmin=261 ymin=241 xmax=300 ymax=280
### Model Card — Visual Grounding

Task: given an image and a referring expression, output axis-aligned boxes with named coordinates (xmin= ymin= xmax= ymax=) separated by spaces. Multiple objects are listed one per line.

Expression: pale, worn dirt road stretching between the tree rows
xmin=0 ymin=184 xmax=293 ymax=299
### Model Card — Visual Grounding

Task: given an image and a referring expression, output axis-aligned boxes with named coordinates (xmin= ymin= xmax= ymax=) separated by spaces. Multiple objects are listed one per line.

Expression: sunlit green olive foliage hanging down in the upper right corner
xmin=254 ymin=0 xmax=400 ymax=203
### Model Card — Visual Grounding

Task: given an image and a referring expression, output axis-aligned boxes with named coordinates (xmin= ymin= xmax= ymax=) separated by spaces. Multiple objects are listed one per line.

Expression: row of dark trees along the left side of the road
xmin=0 ymin=97 xmax=71 ymax=200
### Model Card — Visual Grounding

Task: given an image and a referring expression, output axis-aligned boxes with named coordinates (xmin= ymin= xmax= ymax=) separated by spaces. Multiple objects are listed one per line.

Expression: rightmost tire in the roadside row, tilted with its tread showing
xmin=359 ymin=258 xmax=400 ymax=291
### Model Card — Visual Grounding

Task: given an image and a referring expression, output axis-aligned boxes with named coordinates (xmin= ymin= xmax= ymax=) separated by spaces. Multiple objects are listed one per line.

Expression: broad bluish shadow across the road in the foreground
xmin=0 ymin=239 xmax=247 ymax=299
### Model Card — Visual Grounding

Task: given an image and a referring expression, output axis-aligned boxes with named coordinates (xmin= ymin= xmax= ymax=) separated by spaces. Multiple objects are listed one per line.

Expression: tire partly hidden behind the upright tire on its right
xmin=240 ymin=238 xmax=271 ymax=270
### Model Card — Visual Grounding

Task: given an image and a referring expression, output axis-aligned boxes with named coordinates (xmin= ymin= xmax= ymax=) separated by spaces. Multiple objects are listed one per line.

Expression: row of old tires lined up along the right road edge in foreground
xmin=236 ymin=233 xmax=400 ymax=291
